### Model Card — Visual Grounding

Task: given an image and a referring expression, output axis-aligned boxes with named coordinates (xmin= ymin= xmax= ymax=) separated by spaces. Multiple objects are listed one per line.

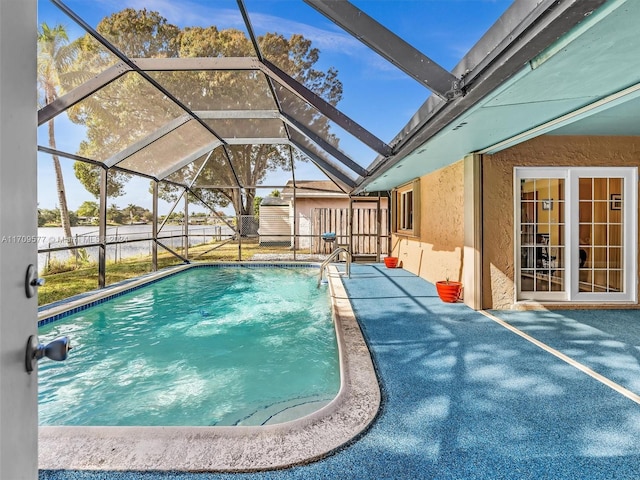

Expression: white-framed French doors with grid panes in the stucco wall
xmin=514 ymin=167 xmax=638 ymax=303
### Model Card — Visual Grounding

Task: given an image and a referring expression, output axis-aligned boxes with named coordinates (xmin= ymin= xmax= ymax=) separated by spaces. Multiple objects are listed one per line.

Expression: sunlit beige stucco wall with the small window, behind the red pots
xmin=392 ymin=161 xmax=464 ymax=282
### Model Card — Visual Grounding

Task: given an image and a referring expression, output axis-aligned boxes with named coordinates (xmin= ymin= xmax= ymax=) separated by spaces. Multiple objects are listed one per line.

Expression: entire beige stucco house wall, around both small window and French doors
xmin=392 ymin=135 xmax=640 ymax=309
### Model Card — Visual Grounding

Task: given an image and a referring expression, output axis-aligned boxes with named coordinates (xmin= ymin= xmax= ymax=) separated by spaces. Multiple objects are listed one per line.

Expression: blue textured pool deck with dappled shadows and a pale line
xmin=40 ymin=264 xmax=640 ymax=480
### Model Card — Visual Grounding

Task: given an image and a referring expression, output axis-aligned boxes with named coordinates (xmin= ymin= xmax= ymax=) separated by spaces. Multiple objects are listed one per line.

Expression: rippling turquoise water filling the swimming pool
xmin=38 ymin=267 xmax=340 ymax=426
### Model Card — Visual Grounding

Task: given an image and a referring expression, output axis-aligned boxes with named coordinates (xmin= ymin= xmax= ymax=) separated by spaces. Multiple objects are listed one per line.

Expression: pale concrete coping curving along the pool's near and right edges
xmin=38 ymin=262 xmax=381 ymax=472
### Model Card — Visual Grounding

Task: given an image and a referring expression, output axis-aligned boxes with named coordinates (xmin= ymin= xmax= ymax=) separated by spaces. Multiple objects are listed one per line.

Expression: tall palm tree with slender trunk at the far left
xmin=38 ymin=22 xmax=75 ymax=245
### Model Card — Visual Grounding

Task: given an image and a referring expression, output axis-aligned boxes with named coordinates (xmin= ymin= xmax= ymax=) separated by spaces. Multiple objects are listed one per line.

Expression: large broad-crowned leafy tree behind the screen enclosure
xmin=67 ymin=9 xmax=342 ymax=215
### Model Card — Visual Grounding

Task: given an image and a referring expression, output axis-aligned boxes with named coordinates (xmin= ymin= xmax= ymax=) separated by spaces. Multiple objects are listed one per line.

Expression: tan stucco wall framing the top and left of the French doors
xmin=482 ymin=136 xmax=640 ymax=309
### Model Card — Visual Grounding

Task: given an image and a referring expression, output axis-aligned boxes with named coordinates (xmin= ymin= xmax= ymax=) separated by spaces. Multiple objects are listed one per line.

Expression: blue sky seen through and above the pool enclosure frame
xmin=38 ymin=0 xmax=513 ymax=214
